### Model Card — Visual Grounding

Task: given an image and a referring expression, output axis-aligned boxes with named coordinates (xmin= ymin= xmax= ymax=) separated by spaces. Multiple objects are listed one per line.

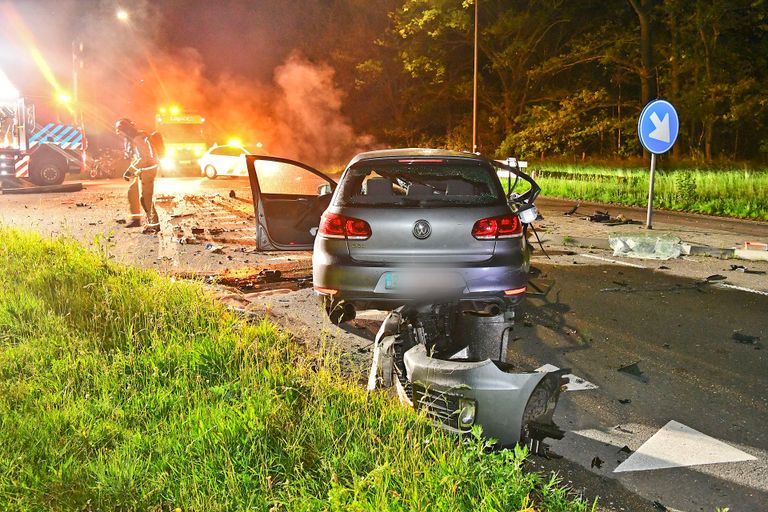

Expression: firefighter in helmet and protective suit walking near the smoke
xmin=115 ymin=118 xmax=160 ymax=233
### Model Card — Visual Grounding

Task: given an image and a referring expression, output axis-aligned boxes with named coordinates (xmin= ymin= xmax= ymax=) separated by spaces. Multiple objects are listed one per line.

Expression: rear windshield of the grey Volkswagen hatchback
xmin=336 ymin=159 xmax=505 ymax=207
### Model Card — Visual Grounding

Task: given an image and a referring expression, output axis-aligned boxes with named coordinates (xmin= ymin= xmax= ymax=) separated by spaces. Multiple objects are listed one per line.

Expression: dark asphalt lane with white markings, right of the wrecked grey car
xmin=510 ymin=263 xmax=768 ymax=511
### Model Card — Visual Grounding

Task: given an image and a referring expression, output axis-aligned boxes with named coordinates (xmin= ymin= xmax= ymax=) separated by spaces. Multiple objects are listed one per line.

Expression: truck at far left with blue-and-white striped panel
xmin=0 ymin=98 xmax=87 ymax=186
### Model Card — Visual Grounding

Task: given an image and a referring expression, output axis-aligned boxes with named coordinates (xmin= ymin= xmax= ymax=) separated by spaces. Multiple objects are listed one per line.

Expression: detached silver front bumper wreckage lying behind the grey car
xmin=368 ymin=302 xmax=568 ymax=453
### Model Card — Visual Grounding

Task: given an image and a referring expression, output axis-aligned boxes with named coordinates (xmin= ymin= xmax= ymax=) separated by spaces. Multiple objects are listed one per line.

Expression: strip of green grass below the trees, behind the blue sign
xmin=528 ymin=162 xmax=768 ymax=220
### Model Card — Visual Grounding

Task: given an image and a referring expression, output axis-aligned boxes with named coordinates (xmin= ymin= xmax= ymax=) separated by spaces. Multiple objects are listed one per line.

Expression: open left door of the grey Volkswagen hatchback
xmin=245 ymin=155 xmax=336 ymax=251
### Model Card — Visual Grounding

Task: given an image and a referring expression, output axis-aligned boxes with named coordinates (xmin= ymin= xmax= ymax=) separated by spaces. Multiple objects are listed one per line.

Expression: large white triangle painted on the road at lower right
xmin=613 ymin=421 xmax=756 ymax=473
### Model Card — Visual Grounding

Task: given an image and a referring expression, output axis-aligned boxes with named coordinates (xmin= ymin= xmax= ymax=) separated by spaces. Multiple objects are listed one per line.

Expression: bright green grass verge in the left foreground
xmin=0 ymin=227 xmax=594 ymax=512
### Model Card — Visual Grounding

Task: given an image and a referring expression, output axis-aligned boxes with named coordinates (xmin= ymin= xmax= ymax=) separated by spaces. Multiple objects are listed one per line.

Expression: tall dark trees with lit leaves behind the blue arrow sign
xmin=314 ymin=0 xmax=768 ymax=161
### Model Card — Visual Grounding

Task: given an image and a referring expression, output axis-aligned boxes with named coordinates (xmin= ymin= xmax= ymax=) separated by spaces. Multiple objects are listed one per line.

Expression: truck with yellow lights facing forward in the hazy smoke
xmin=155 ymin=106 xmax=208 ymax=174
